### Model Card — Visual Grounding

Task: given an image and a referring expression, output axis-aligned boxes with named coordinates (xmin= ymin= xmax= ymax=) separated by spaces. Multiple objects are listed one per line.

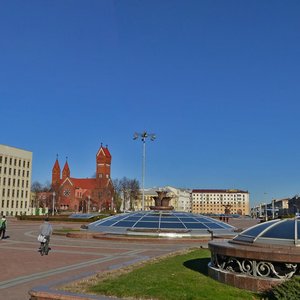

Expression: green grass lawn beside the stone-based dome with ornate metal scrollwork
xmin=63 ymin=249 xmax=260 ymax=300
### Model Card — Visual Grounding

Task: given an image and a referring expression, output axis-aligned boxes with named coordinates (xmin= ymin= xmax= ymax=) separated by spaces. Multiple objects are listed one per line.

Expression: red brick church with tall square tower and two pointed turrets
xmin=52 ymin=144 xmax=114 ymax=212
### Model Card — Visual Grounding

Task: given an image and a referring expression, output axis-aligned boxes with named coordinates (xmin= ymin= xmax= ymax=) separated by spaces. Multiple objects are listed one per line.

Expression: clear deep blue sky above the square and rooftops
xmin=0 ymin=0 xmax=300 ymax=205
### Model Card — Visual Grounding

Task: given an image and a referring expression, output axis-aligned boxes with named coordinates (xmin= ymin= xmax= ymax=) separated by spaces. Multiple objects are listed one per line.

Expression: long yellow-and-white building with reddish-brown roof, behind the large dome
xmin=192 ymin=189 xmax=250 ymax=215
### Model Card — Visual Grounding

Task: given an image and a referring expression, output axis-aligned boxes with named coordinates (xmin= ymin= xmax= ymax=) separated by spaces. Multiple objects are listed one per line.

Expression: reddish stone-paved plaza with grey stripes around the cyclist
xmin=0 ymin=218 xmax=207 ymax=300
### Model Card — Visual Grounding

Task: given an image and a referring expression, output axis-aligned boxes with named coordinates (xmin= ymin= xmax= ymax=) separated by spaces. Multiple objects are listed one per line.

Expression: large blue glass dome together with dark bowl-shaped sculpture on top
xmin=88 ymin=190 xmax=235 ymax=239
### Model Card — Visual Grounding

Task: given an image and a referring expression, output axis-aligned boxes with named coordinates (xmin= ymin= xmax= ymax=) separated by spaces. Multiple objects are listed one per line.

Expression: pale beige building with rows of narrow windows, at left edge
xmin=0 ymin=145 xmax=32 ymax=216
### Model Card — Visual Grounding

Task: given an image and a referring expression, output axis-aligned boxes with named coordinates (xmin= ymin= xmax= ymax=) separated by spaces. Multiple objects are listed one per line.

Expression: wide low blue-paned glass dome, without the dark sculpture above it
xmin=88 ymin=210 xmax=235 ymax=235
